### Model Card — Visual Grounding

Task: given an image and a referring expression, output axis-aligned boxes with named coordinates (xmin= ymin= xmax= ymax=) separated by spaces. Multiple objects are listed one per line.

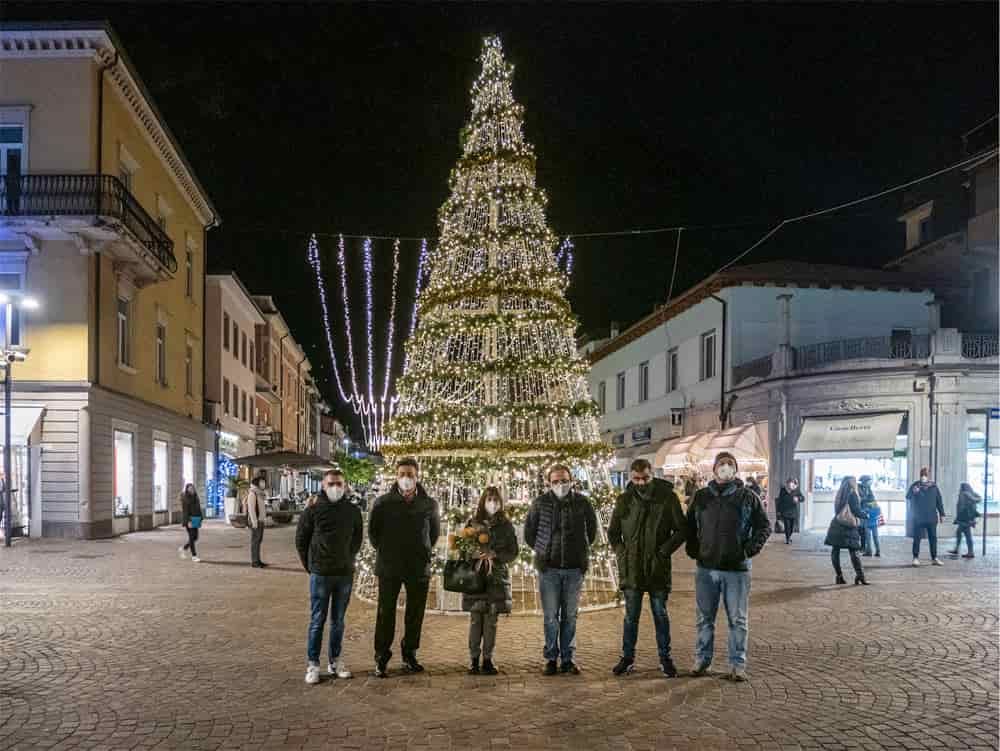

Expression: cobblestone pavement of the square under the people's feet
xmin=0 ymin=524 xmax=1000 ymax=751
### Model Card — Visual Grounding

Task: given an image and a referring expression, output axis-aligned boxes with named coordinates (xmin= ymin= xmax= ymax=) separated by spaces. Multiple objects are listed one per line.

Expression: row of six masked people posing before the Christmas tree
xmin=296 ymin=452 xmax=771 ymax=684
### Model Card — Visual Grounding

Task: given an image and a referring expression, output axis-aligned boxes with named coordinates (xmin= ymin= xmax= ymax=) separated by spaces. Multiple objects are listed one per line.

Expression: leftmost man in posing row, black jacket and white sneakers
xmin=295 ymin=469 xmax=364 ymax=684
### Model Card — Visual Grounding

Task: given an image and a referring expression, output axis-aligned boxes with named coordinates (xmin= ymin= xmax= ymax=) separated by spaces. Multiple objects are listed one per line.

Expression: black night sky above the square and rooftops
xmin=0 ymin=2 xmax=998 ymax=434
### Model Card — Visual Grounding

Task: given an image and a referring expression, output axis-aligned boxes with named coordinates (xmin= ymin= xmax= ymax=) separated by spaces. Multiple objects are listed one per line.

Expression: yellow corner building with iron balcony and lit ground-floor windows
xmin=0 ymin=25 xmax=219 ymax=537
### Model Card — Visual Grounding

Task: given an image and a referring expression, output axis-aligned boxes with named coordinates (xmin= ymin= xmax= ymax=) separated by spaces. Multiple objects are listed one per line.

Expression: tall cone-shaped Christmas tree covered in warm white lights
xmin=352 ymin=37 xmax=616 ymax=611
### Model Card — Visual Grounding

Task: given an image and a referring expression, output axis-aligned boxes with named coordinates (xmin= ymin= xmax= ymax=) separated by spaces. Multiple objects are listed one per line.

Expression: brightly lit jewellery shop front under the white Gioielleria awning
xmin=794 ymin=412 xmax=910 ymax=534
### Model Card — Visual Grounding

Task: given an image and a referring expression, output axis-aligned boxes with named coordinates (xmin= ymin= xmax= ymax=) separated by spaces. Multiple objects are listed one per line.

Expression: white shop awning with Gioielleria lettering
xmin=795 ymin=412 xmax=904 ymax=460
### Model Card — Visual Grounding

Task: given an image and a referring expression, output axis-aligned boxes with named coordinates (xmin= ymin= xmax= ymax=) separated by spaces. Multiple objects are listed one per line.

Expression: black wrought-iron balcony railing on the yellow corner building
xmin=0 ymin=175 xmax=177 ymax=274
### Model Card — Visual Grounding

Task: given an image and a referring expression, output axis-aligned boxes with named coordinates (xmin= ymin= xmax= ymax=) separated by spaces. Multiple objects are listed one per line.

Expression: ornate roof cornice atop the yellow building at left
xmin=0 ymin=24 xmax=219 ymax=226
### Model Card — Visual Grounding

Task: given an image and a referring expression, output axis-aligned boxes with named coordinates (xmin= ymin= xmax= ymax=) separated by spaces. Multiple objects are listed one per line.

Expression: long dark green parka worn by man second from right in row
xmin=608 ymin=478 xmax=687 ymax=592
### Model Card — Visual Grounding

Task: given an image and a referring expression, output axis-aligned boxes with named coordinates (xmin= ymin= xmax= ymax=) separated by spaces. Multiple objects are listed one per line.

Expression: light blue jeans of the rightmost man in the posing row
xmin=694 ymin=566 xmax=750 ymax=668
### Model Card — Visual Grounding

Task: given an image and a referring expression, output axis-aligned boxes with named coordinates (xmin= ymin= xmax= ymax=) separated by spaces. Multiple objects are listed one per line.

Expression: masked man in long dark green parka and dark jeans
xmin=608 ymin=459 xmax=687 ymax=678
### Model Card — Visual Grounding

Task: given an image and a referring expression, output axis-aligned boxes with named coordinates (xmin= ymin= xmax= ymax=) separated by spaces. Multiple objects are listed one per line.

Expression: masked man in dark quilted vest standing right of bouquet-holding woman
xmin=524 ymin=464 xmax=597 ymax=675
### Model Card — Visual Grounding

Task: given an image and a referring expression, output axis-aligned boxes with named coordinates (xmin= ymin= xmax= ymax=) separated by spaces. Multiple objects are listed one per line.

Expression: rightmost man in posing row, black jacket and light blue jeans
xmin=687 ymin=451 xmax=771 ymax=681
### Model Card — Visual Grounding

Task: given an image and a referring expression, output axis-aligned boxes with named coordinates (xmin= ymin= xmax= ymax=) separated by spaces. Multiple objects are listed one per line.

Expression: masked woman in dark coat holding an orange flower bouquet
xmin=462 ymin=485 xmax=518 ymax=675
